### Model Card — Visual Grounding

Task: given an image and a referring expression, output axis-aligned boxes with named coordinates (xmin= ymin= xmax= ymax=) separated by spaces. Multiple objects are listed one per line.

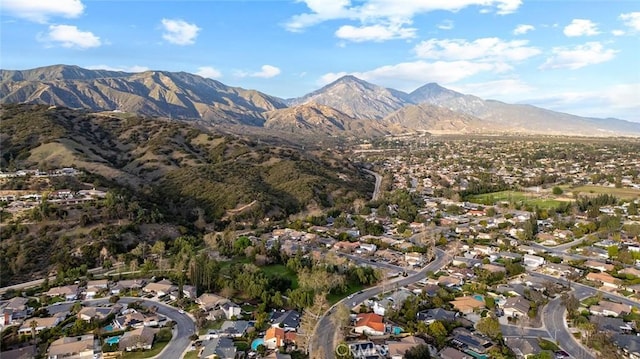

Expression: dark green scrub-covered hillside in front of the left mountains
xmin=0 ymin=105 xmax=373 ymax=285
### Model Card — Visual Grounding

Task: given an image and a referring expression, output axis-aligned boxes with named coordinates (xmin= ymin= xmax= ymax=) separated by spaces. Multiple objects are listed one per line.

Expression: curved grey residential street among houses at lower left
xmin=83 ymin=297 xmax=196 ymax=358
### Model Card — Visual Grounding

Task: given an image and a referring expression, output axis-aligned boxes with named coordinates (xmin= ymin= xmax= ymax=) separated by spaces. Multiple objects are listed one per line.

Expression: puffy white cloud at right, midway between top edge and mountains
xmin=540 ymin=41 xmax=617 ymax=70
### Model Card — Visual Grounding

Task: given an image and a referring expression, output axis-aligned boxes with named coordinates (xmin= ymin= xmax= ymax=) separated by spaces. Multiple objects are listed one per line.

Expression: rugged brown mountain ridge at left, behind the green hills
xmin=0 ymin=65 xmax=286 ymax=125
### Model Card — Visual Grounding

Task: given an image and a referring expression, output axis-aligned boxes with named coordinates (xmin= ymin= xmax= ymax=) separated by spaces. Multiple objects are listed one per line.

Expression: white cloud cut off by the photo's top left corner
xmin=2 ymin=0 xmax=84 ymax=23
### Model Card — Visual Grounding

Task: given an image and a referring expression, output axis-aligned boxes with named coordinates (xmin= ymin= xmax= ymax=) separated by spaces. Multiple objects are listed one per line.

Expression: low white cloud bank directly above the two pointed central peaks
xmin=319 ymin=60 xmax=504 ymax=91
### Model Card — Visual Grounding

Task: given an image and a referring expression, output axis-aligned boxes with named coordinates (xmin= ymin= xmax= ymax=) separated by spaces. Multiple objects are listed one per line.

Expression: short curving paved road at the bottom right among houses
xmin=542 ymin=297 xmax=595 ymax=359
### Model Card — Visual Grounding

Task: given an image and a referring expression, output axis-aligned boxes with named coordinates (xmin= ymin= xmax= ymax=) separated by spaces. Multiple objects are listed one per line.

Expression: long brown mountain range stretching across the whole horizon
xmin=0 ymin=65 xmax=640 ymax=136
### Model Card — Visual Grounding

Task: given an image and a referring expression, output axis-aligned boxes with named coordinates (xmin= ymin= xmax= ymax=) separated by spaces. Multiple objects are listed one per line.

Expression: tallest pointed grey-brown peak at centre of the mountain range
xmin=287 ymin=76 xmax=410 ymax=120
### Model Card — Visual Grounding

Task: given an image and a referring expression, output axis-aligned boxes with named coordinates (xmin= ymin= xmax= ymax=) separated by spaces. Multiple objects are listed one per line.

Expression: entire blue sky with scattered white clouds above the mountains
xmin=0 ymin=0 xmax=640 ymax=122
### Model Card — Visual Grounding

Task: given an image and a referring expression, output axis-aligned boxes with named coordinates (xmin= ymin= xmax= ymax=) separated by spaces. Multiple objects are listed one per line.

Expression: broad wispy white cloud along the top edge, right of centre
xmin=284 ymin=0 xmax=522 ymax=41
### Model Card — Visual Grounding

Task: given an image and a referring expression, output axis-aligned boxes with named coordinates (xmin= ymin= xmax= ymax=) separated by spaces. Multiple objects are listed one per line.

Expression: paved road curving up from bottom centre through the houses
xmin=309 ymin=248 xmax=451 ymax=358
